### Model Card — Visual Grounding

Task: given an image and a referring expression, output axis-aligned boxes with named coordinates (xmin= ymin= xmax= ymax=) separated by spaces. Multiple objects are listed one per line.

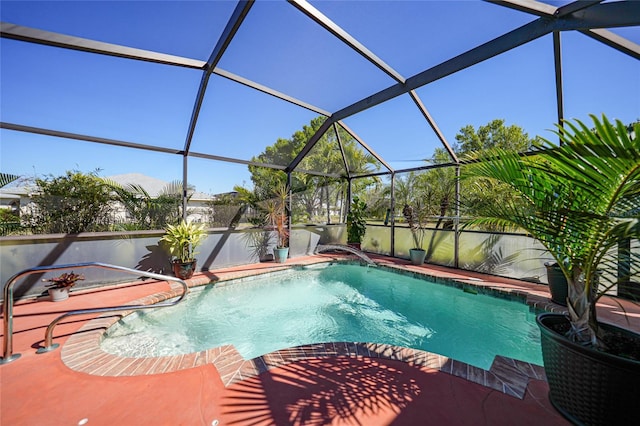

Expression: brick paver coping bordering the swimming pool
xmin=61 ymin=258 xmax=562 ymax=399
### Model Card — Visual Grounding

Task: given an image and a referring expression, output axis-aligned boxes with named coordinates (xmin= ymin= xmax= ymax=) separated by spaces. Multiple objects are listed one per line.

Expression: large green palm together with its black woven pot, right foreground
xmin=464 ymin=116 xmax=640 ymax=424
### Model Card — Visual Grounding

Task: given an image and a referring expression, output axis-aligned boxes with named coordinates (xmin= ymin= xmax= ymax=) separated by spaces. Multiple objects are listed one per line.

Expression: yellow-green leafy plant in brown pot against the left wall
xmin=160 ymin=220 xmax=207 ymax=280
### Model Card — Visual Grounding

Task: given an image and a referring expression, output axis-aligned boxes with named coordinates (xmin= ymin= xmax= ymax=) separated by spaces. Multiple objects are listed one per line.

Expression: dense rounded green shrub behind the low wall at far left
xmin=25 ymin=171 xmax=113 ymax=234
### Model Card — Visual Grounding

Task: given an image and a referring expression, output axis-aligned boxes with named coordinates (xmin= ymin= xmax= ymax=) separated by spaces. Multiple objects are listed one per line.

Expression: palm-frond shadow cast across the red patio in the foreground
xmin=220 ymin=356 xmax=567 ymax=425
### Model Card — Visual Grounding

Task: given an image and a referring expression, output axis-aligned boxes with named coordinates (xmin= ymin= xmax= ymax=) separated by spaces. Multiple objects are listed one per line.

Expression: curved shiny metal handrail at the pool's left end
xmin=0 ymin=262 xmax=189 ymax=365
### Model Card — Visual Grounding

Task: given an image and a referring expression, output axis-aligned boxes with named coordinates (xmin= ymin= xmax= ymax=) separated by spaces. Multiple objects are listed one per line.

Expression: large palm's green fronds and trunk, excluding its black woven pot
xmin=463 ymin=115 xmax=640 ymax=347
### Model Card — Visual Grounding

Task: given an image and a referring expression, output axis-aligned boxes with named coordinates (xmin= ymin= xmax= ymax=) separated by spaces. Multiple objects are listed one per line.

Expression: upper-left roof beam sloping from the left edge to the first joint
xmin=0 ymin=22 xmax=206 ymax=70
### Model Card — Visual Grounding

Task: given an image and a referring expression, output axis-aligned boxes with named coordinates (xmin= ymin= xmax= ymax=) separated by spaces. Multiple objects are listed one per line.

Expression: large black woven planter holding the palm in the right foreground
xmin=536 ymin=313 xmax=640 ymax=425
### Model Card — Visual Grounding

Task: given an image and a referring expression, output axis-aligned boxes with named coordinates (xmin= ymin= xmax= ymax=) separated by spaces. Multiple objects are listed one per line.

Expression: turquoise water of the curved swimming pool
xmin=101 ymin=264 xmax=542 ymax=369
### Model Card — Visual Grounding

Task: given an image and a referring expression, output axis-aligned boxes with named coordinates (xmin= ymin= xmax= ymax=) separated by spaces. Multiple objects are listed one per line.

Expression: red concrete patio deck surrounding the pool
xmin=0 ymin=255 xmax=640 ymax=425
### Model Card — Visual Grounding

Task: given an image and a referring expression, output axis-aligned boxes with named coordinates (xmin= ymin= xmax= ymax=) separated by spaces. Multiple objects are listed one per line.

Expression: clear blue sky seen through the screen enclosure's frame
xmin=0 ymin=1 xmax=640 ymax=193
